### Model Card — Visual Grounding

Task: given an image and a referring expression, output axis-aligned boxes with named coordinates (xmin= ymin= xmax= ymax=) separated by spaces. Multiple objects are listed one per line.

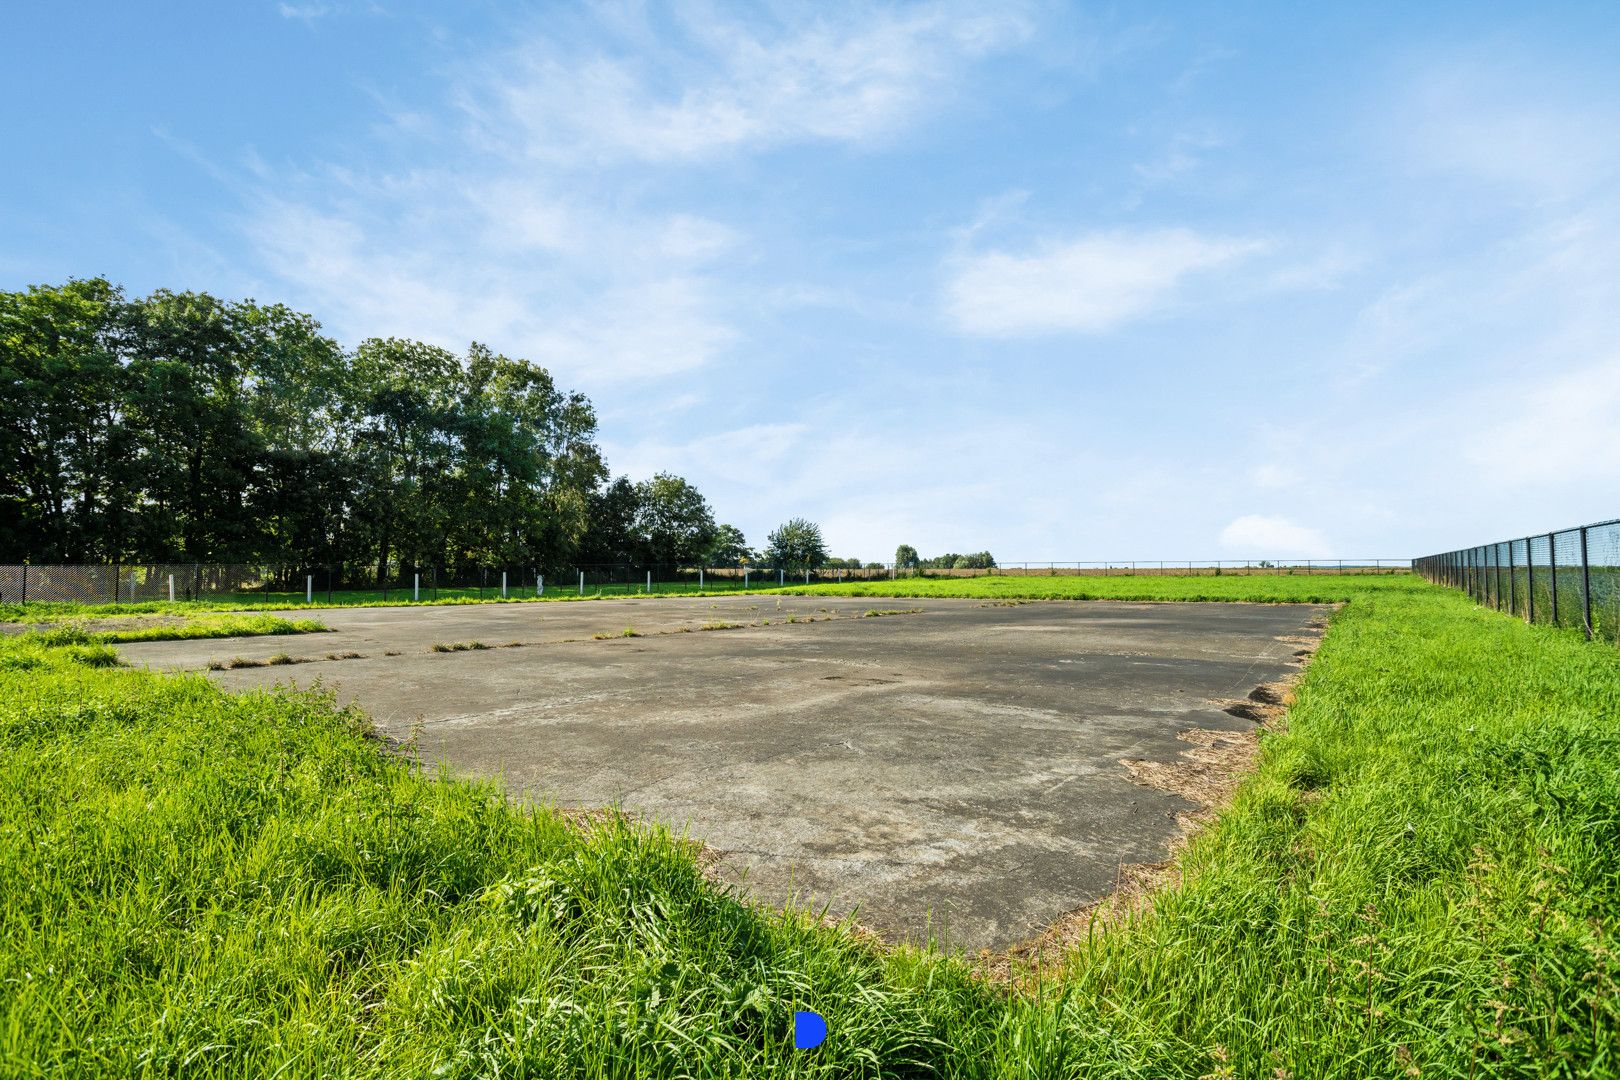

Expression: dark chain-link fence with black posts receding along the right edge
xmin=1413 ymin=521 xmax=1620 ymax=641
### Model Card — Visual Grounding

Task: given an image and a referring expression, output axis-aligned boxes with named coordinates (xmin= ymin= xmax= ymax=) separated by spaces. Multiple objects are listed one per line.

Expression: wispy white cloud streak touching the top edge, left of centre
xmin=462 ymin=3 xmax=1032 ymax=164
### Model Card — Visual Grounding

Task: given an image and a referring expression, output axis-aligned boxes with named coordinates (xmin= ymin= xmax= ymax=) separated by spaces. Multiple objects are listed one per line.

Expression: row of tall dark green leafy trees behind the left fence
xmin=0 ymin=279 xmax=847 ymax=575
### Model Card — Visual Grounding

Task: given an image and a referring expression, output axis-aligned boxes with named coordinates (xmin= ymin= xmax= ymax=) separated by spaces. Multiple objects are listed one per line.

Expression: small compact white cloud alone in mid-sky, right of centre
xmin=944 ymin=228 xmax=1265 ymax=337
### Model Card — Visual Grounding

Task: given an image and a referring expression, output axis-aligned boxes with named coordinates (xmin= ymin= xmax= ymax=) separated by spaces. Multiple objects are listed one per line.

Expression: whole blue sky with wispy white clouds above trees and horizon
xmin=0 ymin=0 xmax=1620 ymax=560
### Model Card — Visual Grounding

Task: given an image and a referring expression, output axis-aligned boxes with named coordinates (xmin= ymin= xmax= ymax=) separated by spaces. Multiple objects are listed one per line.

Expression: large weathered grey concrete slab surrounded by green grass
xmin=120 ymin=596 xmax=1325 ymax=949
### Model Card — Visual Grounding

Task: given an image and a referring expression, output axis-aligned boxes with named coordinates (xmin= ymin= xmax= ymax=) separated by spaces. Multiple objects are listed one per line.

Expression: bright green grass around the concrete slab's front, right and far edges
xmin=0 ymin=576 xmax=1620 ymax=1080
